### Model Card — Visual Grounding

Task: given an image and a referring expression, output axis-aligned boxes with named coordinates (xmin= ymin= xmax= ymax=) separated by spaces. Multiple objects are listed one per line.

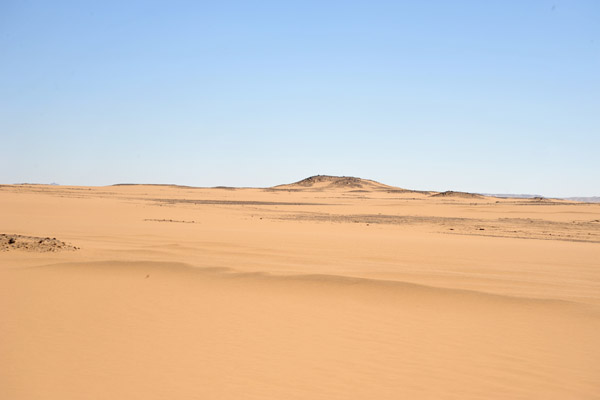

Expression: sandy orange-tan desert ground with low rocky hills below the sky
xmin=0 ymin=177 xmax=600 ymax=400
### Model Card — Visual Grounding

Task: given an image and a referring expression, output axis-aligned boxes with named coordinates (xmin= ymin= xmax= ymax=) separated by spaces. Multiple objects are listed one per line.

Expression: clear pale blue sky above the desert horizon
xmin=0 ymin=0 xmax=600 ymax=196
